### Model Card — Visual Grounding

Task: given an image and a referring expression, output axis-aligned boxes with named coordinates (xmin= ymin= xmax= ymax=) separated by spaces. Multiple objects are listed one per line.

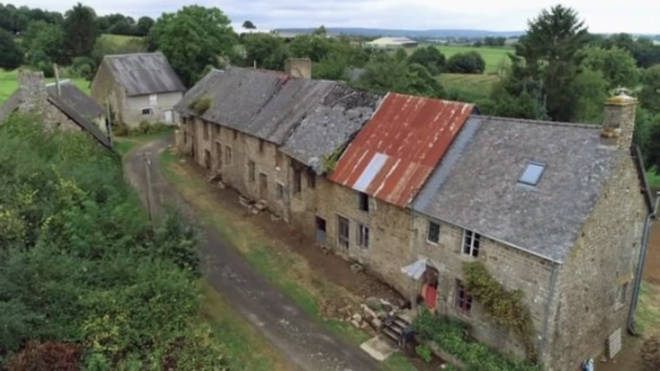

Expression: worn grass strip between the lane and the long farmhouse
xmin=161 ymin=151 xmax=376 ymax=344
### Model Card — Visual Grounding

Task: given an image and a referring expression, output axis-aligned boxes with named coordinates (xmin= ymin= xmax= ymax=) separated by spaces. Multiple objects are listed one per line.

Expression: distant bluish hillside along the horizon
xmin=275 ymin=27 xmax=524 ymax=38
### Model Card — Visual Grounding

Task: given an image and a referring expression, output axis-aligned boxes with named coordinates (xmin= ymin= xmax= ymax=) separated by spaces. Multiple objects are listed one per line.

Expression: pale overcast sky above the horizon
xmin=9 ymin=0 xmax=660 ymax=34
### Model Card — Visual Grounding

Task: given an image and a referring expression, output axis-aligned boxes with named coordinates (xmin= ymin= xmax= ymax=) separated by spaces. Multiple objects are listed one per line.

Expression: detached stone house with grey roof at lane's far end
xmin=92 ymin=53 xmax=186 ymax=128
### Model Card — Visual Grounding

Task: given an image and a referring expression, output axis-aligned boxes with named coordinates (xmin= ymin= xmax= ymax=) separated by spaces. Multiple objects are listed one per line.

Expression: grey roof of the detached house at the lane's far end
xmin=103 ymin=53 xmax=186 ymax=96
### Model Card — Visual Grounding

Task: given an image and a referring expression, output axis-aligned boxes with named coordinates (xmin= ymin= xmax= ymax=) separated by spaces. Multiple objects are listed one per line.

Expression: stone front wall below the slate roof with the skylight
xmin=412 ymin=213 xmax=555 ymax=357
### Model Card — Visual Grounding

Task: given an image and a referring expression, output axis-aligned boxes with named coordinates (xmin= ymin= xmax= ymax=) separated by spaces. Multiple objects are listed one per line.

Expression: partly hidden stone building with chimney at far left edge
xmin=0 ymin=71 xmax=112 ymax=148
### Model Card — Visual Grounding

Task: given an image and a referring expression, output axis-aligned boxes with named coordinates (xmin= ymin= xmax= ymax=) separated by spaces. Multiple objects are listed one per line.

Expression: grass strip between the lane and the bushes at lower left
xmin=201 ymin=282 xmax=289 ymax=371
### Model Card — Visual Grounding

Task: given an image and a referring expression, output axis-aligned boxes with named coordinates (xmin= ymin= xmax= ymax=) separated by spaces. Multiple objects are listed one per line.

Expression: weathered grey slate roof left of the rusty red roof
xmin=175 ymin=67 xmax=379 ymax=174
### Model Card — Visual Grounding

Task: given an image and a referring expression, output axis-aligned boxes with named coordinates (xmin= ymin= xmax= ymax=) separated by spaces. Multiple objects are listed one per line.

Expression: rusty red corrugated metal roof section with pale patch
xmin=330 ymin=93 xmax=474 ymax=207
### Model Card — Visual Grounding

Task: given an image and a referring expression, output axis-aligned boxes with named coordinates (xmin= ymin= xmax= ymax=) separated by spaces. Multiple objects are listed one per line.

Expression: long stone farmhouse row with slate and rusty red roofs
xmin=175 ymin=62 xmax=655 ymax=370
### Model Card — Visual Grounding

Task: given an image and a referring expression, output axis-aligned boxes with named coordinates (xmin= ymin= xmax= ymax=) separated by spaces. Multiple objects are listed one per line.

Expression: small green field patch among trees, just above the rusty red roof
xmin=438 ymin=73 xmax=500 ymax=102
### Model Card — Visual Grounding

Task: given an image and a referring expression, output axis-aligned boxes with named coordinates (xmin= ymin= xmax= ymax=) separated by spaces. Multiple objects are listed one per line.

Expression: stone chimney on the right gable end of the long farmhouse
xmin=600 ymin=93 xmax=637 ymax=149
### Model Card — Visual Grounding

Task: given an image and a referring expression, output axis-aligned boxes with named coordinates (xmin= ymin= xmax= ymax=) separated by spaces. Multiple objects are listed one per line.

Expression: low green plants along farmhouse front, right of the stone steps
xmin=413 ymin=311 xmax=541 ymax=371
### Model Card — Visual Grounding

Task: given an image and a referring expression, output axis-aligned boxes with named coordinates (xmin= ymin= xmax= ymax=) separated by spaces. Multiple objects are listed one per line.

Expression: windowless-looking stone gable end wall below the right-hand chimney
xmin=545 ymin=149 xmax=648 ymax=370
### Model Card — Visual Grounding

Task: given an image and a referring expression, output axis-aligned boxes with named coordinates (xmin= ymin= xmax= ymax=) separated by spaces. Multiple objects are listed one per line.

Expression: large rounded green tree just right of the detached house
xmin=149 ymin=5 xmax=236 ymax=86
